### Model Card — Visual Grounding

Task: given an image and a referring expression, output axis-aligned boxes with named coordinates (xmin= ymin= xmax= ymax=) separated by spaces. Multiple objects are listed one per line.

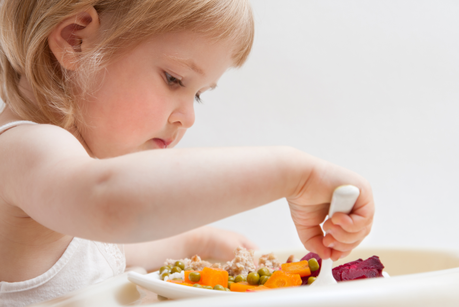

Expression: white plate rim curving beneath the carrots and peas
xmin=128 ymin=271 xmax=244 ymax=299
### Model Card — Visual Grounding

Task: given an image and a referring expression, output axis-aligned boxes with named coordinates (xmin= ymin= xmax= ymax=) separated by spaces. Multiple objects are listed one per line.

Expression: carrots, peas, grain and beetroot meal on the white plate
xmin=159 ymin=247 xmax=384 ymax=292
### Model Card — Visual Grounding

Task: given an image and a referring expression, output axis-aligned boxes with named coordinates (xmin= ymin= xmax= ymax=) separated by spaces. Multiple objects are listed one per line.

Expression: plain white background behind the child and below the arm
xmin=1 ymin=0 xmax=459 ymax=250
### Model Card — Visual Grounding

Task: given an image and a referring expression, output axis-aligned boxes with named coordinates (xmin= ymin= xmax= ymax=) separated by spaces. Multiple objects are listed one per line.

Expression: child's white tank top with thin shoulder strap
xmin=0 ymin=121 xmax=126 ymax=307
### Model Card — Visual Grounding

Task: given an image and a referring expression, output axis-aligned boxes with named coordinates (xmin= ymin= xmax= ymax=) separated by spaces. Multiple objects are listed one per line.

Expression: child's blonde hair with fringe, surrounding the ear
xmin=0 ymin=0 xmax=254 ymax=129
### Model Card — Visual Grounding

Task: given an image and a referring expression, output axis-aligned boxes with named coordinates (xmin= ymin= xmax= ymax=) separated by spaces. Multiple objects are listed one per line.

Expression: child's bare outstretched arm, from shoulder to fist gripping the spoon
xmin=0 ymin=125 xmax=373 ymax=257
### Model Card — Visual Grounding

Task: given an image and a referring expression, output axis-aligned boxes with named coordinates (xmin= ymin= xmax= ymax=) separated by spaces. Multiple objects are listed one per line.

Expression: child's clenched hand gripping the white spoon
xmin=287 ymin=161 xmax=375 ymax=261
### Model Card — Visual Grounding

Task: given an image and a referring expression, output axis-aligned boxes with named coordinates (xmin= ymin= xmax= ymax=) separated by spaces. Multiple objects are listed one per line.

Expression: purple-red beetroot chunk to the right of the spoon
xmin=333 ymin=256 xmax=384 ymax=282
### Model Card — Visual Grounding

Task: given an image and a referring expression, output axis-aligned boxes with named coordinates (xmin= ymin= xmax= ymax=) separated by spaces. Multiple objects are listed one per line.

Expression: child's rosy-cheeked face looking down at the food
xmin=79 ymin=32 xmax=232 ymax=158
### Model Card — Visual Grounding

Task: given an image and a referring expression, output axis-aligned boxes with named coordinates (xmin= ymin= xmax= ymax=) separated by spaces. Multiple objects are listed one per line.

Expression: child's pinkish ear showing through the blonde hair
xmin=48 ymin=7 xmax=100 ymax=70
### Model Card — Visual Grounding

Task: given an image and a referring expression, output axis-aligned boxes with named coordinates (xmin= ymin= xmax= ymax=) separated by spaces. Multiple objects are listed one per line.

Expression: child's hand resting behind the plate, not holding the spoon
xmin=187 ymin=226 xmax=258 ymax=261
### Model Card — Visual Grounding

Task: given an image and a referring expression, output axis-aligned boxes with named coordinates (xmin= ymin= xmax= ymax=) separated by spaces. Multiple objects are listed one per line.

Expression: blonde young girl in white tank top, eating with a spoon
xmin=0 ymin=0 xmax=374 ymax=306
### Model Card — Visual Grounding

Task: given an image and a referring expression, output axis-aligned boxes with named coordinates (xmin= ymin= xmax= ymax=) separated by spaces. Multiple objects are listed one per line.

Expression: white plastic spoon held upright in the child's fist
xmin=311 ymin=185 xmax=360 ymax=286
